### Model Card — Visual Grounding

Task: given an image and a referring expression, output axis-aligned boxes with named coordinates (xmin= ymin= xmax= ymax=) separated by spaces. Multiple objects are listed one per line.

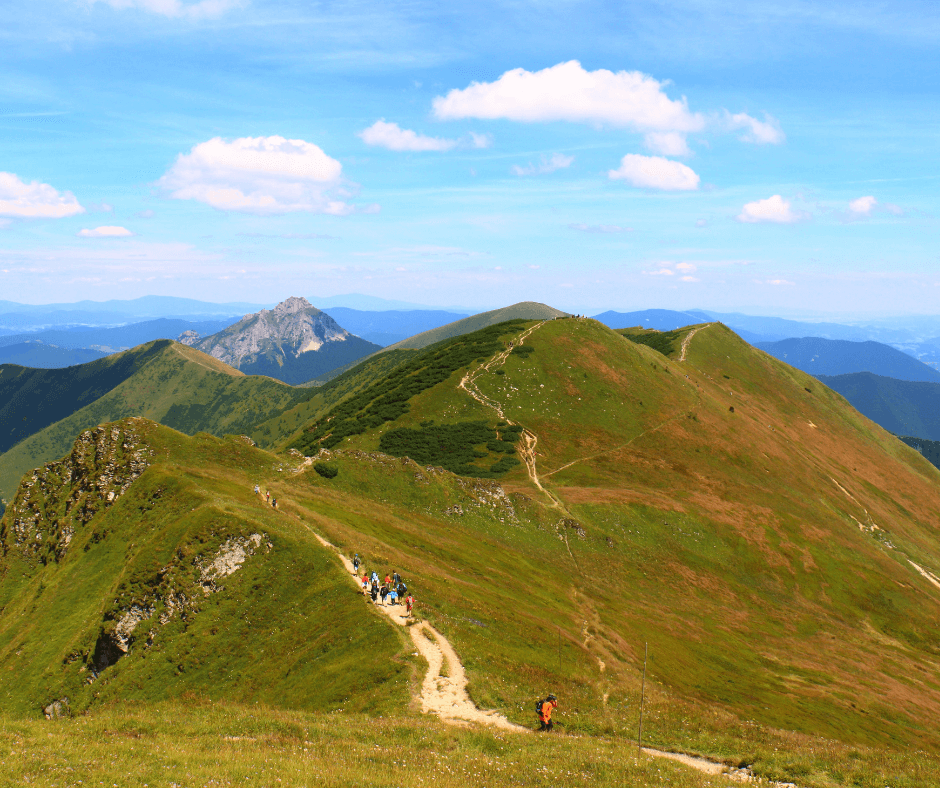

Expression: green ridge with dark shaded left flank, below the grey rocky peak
xmin=0 ymin=340 xmax=298 ymax=498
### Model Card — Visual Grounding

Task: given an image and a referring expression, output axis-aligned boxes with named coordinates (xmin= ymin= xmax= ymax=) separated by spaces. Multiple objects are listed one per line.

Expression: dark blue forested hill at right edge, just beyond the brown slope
xmin=818 ymin=372 xmax=940 ymax=441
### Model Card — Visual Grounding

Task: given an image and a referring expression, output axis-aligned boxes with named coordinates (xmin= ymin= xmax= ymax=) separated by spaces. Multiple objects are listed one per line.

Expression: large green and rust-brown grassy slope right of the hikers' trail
xmin=284 ymin=320 xmax=940 ymax=747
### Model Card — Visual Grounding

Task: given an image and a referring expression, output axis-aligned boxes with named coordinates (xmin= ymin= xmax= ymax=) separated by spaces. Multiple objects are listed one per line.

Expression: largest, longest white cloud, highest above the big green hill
xmin=433 ymin=60 xmax=705 ymax=132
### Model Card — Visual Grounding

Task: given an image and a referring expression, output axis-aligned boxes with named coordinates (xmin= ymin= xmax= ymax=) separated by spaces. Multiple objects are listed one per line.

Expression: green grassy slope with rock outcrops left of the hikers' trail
xmin=0 ymin=419 xmax=410 ymax=714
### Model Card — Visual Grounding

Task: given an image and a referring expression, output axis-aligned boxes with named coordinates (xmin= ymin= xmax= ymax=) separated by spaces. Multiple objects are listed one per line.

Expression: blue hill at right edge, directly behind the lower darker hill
xmin=755 ymin=337 xmax=940 ymax=383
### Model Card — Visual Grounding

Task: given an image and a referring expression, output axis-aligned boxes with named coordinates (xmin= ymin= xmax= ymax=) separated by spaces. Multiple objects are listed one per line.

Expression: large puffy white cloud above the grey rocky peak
xmin=157 ymin=136 xmax=353 ymax=215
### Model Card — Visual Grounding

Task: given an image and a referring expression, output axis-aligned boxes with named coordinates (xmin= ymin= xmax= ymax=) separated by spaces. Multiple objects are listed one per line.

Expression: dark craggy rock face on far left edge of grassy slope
xmin=0 ymin=419 xmax=152 ymax=563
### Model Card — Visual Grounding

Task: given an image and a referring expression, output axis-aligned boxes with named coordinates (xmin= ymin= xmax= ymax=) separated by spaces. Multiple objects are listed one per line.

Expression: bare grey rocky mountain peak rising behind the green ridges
xmin=179 ymin=296 xmax=381 ymax=383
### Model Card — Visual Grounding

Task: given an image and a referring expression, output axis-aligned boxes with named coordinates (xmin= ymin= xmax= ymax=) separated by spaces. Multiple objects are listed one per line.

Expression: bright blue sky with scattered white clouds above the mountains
xmin=0 ymin=0 xmax=940 ymax=318
